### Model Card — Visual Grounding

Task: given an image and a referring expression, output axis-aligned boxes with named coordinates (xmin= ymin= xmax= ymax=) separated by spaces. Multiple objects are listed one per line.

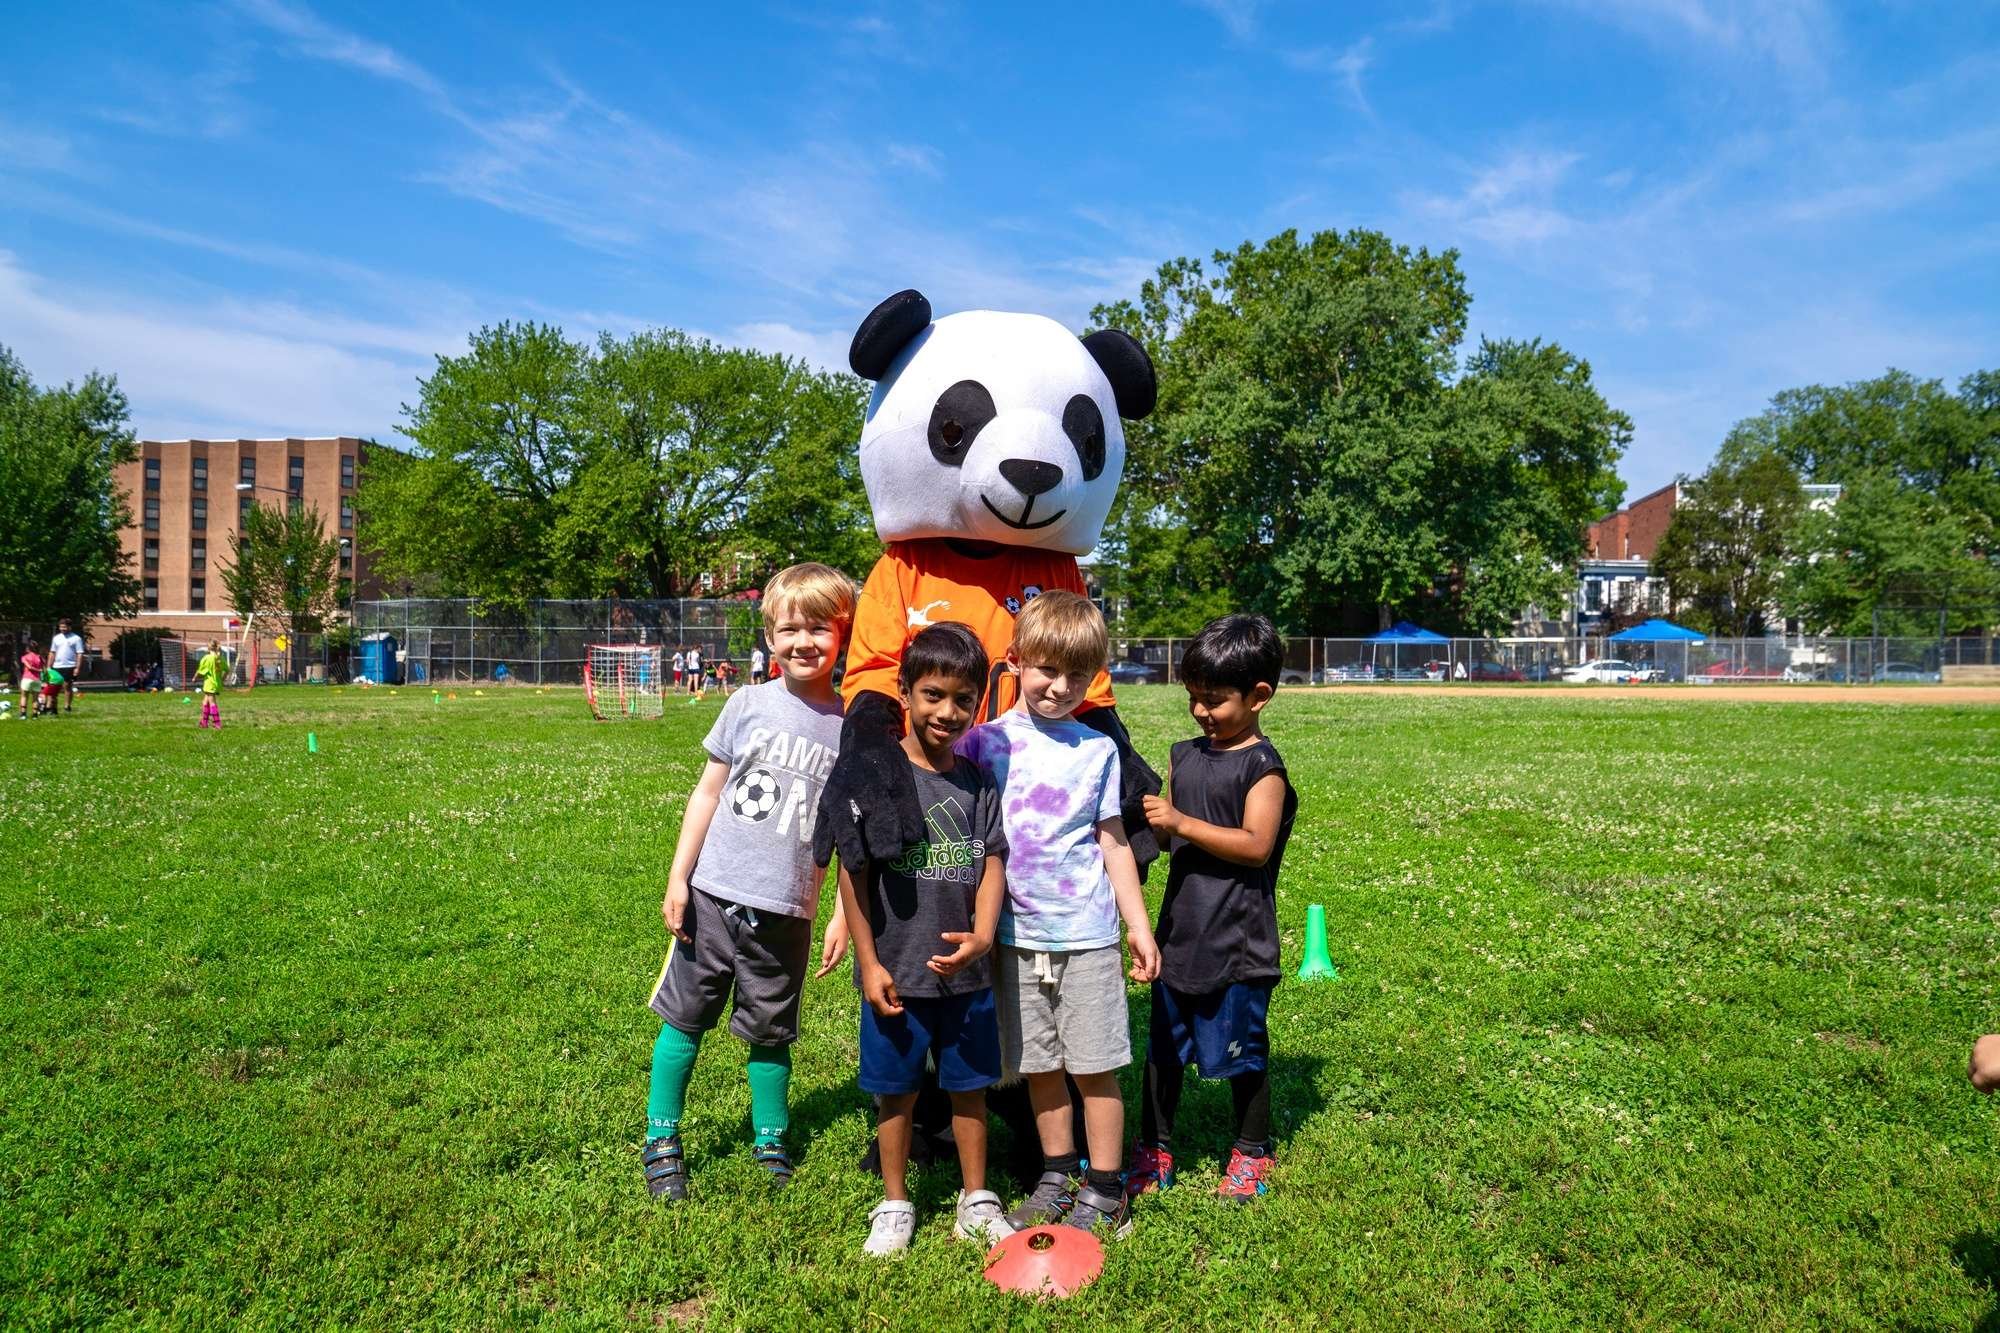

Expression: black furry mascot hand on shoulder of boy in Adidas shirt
xmin=812 ymin=691 xmax=924 ymax=871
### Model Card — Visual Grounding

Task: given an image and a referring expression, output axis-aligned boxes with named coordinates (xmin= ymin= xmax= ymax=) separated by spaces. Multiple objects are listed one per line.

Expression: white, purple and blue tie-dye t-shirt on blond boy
xmin=958 ymin=709 xmax=1118 ymax=953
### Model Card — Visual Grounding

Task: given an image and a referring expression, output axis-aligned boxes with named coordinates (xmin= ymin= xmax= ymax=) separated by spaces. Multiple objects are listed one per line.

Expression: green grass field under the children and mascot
xmin=0 ymin=687 xmax=2000 ymax=1329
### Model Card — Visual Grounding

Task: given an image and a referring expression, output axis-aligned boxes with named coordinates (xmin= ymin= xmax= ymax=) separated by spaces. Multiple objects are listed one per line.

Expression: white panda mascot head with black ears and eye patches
xmin=848 ymin=292 xmax=1156 ymax=554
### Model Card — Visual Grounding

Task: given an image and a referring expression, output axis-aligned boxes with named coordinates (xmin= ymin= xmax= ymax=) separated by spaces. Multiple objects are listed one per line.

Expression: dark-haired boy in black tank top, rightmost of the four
xmin=1126 ymin=614 xmax=1298 ymax=1203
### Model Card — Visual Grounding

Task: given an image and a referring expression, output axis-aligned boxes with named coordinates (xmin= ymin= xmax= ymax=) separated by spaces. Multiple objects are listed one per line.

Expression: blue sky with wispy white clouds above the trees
xmin=0 ymin=0 xmax=2000 ymax=494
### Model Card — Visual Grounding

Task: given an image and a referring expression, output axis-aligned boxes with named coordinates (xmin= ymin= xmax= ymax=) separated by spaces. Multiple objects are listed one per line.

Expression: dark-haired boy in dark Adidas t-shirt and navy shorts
xmin=840 ymin=624 xmax=1014 ymax=1255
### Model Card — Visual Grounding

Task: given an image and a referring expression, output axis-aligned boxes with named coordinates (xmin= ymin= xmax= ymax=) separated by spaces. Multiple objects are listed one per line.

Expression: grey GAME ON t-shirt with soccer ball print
xmin=688 ymin=681 xmax=840 ymax=921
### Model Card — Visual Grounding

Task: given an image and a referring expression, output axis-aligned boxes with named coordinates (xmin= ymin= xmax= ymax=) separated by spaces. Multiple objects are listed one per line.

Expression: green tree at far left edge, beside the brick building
xmin=0 ymin=346 xmax=140 ymax=624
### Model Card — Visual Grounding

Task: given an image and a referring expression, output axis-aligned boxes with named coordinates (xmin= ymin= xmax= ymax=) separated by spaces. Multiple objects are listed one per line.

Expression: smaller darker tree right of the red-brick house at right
xmin=1652 ymin=452 xmax=1806 ymax=638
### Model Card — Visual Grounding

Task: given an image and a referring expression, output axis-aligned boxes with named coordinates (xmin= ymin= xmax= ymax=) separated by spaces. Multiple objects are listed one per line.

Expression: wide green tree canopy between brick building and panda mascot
xmin=356 ymin=324 xmax=876 ymax=604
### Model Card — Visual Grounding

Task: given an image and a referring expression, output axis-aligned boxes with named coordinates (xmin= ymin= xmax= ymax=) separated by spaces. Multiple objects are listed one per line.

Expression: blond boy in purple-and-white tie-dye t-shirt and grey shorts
xmin=964 ymin=590 xmax=1160 ymax=1235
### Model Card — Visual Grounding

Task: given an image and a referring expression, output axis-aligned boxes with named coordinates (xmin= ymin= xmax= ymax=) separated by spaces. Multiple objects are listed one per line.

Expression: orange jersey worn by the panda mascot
xmin=840 ymin=538 xmax=1114 ymax=719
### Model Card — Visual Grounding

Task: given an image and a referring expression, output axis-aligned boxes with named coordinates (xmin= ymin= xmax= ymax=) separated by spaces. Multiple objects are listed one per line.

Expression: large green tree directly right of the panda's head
xmin=1094 ymin=230 xmax=1630 ymax=632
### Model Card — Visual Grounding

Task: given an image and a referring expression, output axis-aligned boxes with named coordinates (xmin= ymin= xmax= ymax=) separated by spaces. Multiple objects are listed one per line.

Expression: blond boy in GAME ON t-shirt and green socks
xmin=642 ymin=564 xmax=854 ymax=1199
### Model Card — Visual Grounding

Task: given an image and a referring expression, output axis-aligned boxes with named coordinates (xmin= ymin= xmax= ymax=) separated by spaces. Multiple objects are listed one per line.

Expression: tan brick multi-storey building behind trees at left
xmin=92 ymin=436 xmax=378 ymax=650
